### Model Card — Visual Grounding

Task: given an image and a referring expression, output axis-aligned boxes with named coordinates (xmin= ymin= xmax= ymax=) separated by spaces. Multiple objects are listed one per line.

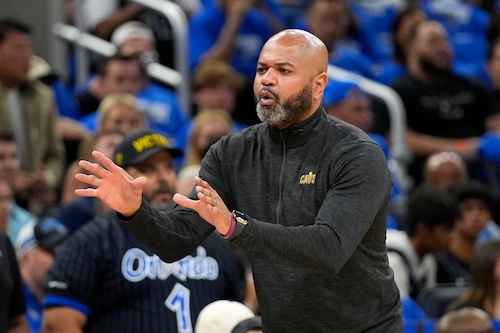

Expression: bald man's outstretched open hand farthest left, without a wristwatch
xmin=75 ymin=151 xmax=147 ymax=217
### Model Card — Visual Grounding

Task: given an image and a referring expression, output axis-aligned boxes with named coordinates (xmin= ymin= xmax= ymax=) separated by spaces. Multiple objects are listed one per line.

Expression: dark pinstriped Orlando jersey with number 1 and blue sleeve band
xmin=44 ymin=212 xmax=243 ymax=333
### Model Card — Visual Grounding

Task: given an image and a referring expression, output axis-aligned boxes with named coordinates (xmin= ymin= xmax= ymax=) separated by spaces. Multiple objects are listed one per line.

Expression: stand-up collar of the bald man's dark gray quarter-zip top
xmin=268 ymin=107 xmax=326 ymax=148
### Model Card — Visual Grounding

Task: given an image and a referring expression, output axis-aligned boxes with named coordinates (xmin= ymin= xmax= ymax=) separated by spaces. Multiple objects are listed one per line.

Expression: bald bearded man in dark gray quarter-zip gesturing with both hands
xmin=76 ymin=30 xmax=402 ymax=333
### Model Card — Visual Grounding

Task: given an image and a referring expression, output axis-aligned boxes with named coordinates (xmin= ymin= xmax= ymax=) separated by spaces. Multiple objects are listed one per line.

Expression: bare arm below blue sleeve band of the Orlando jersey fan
xmin=42 ymin=307 xmax=87 ymax=333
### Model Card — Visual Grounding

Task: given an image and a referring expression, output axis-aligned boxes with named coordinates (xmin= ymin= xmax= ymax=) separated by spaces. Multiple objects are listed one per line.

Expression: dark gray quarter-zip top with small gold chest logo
xmin=123 ymin=109 xmax=403 ymax=333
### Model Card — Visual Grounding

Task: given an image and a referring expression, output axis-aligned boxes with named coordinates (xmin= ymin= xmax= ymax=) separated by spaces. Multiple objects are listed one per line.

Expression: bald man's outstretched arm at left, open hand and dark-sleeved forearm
xmin=75 ymin=151 xmax=219 ymax=262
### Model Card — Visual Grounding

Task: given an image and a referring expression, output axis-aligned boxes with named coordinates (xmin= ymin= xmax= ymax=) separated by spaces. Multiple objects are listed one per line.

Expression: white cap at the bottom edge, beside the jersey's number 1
xmin=194 ymin=300 xmax=255 ymax=333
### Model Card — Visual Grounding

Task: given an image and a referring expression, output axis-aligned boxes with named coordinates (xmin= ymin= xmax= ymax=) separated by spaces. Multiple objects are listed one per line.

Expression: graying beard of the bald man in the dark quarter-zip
xmin=256 ymin=84 xmax=312 ymax=126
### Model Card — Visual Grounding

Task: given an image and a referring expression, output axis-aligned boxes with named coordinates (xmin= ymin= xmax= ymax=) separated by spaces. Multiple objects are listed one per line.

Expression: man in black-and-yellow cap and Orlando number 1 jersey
xmin=43 ymin=129 xmax=244 ymax=333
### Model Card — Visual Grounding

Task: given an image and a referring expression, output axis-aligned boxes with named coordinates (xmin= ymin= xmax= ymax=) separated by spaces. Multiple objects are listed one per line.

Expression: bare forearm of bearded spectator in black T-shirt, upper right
xmin=406 ymin=129 xmax=479 ymax=159
